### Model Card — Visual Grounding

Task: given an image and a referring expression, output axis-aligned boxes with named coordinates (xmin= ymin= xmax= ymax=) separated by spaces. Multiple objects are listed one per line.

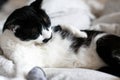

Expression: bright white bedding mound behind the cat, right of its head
xmin=42 ymin=0 xmax=95 ymax=29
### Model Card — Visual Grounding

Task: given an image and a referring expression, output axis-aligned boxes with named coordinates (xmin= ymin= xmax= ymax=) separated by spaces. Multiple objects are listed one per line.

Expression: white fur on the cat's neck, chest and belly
xmin=0 ymin=30 xmax=104 ymax=80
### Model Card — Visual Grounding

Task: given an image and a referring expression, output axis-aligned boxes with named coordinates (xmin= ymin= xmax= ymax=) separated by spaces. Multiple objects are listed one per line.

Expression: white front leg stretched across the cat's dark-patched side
xmin=56 ymin=25 xmax=87 ymax=38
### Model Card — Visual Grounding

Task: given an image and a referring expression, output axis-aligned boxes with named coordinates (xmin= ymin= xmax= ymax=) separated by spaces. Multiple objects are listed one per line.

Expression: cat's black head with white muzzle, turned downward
xmin=3 ymin=0 xmax=52 ymax=43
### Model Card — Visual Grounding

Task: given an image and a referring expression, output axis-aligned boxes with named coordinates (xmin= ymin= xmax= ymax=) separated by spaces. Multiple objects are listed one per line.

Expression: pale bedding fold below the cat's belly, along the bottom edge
xmin=44 ymin=68 xmax=120 ymax=80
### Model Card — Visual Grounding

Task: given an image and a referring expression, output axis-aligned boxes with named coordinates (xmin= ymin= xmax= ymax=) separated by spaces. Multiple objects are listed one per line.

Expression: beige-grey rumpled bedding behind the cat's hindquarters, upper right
xmin=91 ymin=0 xmax=120 ymax=35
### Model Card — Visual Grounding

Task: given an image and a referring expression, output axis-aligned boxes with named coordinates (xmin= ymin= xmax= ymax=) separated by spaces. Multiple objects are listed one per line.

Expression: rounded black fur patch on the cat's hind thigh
xmin=96 ymin=35 xmax=120 ymax=67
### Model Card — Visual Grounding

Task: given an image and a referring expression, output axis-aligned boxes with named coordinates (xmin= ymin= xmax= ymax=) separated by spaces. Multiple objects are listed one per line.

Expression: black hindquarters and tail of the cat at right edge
xmin=96 ymin=35 xmax=120 ymax=77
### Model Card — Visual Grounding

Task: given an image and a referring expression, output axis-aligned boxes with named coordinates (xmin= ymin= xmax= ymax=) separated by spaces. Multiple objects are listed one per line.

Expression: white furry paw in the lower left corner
xmin=0 ymin=55 xmax=15 ymax=77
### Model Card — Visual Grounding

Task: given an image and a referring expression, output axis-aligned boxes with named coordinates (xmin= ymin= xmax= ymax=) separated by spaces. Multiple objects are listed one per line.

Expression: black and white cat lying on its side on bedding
xmin=0 ymin=0 xmax=120 ymax=80
